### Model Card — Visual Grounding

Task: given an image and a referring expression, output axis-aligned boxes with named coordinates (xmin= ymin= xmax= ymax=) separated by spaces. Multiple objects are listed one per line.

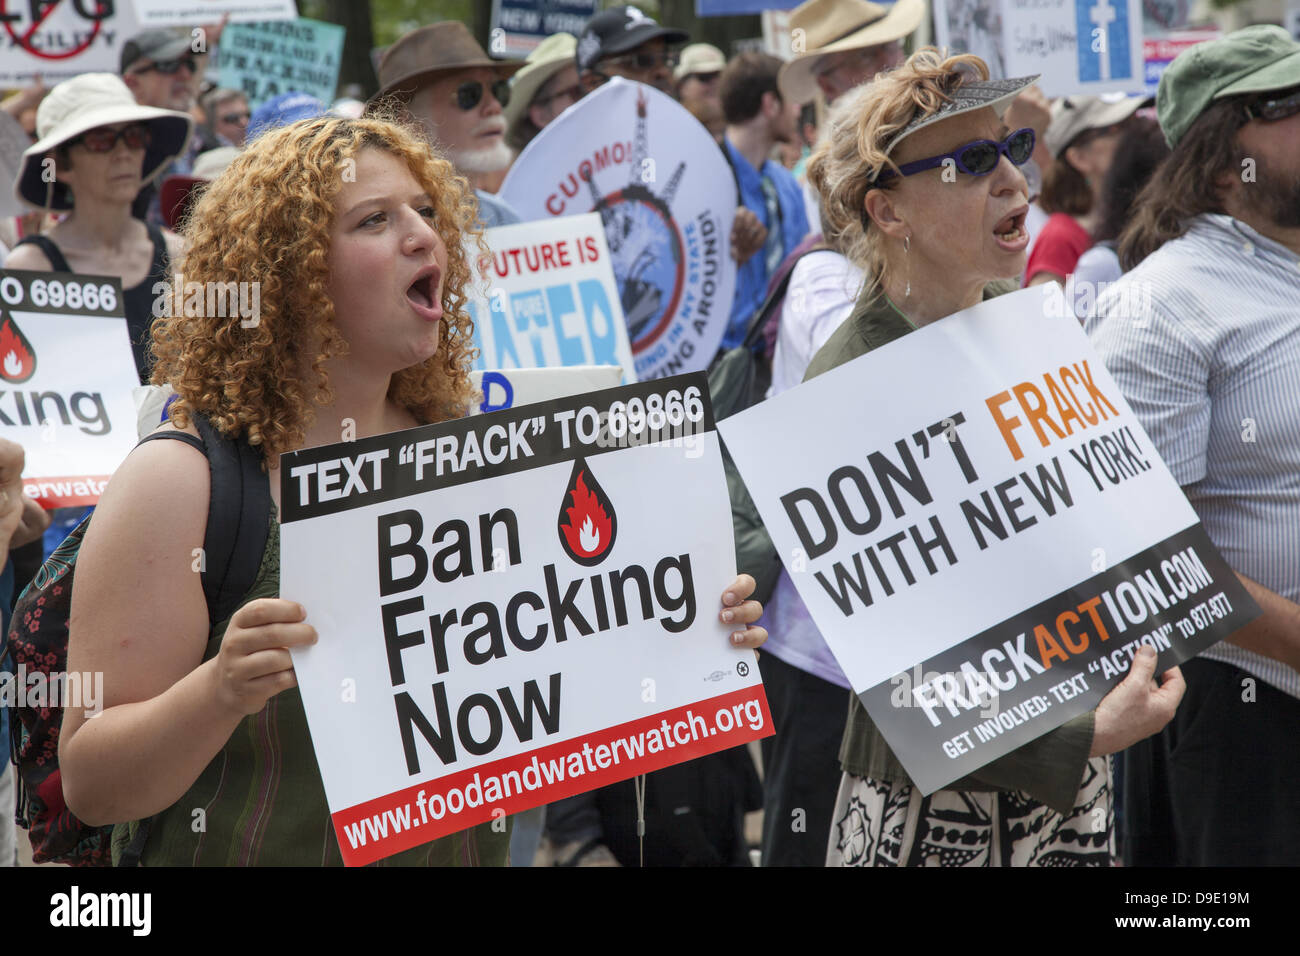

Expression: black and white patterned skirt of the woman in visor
xmin=827 ymin=757 xmax=1114 ymax=866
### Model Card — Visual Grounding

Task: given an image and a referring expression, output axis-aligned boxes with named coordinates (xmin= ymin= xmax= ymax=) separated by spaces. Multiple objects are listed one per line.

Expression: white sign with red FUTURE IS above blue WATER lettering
xmin=469 ymin=213 xmax=637 ymax=382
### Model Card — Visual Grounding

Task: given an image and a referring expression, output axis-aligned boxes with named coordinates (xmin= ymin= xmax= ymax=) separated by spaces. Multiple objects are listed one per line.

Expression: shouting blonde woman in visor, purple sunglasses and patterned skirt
xmin=807 ymin=47 xmax=1183 ymax=866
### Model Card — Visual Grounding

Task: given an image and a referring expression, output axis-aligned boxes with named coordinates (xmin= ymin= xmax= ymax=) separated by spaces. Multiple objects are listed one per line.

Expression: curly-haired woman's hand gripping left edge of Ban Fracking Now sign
xmin=213 ymin=598 xmax=319 ymax=715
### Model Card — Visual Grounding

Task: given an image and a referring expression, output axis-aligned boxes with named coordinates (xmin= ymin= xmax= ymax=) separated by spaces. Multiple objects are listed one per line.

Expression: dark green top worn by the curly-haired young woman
xmin=113 ymin=503 xmax=510 ymax=866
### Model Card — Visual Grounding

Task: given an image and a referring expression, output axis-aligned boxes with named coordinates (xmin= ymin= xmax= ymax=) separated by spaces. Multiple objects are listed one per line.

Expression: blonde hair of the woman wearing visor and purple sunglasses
xmin=807 ymin=47 xmax=988 ymax=293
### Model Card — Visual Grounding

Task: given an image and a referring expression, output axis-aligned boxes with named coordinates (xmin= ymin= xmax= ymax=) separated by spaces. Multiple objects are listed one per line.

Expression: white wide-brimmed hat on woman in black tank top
xmin=13 ymin=73 xmax=194 ymax=209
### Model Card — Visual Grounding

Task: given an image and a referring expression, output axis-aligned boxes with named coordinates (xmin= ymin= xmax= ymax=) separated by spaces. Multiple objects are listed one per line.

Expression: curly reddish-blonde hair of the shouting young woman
xmin=152 ymin=117 xmax=486 ymax=467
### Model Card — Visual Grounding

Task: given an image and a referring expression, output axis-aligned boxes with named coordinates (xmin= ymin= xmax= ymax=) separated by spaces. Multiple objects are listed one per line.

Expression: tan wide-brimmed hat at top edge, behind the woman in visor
xmin=777 ymin=0 xmax=926 ymax=103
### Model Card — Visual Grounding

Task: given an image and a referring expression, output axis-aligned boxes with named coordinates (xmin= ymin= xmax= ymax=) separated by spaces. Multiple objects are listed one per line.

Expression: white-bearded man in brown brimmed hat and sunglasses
xmin=371 ymin=21 xmax=524 ymax=228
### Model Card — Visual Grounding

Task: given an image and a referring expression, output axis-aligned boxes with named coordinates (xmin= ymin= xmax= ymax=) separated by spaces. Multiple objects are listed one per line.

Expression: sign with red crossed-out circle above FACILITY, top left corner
xmin=0 ymin=0 xmax=138 ymax=87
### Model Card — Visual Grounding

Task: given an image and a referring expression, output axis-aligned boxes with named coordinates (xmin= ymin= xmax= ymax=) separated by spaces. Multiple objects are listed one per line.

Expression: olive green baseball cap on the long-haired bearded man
xmin=1156 ymin=25 xmax=1300 ymax=148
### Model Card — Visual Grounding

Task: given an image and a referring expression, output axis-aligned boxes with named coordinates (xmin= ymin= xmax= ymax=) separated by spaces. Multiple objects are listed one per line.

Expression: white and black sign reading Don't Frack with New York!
xmin=719 ymin=285 xmax=1258 ymax=792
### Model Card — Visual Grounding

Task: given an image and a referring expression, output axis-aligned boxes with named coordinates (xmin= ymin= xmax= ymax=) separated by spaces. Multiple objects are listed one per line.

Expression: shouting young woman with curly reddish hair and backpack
xmin=60 ymin=117 xmax=766 ymax=865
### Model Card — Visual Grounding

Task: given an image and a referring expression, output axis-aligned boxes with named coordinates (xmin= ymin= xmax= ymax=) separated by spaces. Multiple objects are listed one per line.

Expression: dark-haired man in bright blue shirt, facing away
xmin=722 ymin=53 xmax=809 ymax=349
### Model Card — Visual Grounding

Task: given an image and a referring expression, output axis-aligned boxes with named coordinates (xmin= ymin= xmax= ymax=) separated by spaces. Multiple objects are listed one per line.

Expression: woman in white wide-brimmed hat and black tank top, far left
xmin=5 ymin=73 xmax=194 ymax=382
